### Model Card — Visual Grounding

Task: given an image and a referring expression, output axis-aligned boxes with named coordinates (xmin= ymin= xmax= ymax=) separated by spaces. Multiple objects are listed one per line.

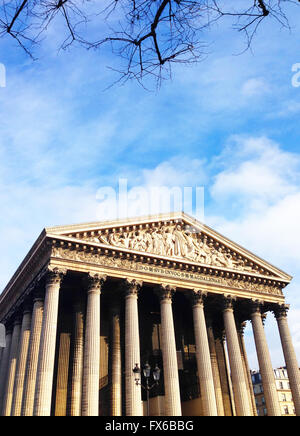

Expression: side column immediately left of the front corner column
xmin=21 ymin=296 xmax=44 ymax=416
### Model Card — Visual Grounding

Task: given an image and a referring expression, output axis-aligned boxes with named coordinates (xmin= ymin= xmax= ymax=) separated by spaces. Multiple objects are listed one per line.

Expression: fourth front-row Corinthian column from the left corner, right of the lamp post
xmin=158 ymin=285 xmax=181 ymax=416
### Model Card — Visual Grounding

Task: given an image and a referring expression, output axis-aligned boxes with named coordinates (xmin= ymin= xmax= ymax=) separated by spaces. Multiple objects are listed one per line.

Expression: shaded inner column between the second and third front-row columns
xmin=110 ymin=304 xmax=122 ymax=416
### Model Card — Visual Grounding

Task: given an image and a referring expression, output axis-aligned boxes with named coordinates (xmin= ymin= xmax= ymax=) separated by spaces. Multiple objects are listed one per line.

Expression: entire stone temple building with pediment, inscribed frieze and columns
xmin=0 ymin=213 xmax=300 ymax=416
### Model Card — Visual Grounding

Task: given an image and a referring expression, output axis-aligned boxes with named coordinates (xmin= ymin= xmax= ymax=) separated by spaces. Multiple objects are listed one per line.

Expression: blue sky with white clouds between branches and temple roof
xmin=0 ymin=3 xmax=300 ymax=367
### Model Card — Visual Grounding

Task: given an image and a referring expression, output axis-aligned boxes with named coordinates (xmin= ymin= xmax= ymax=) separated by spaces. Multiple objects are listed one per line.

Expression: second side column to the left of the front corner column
xmin=11 ymin=307 xmax=31 ymax=416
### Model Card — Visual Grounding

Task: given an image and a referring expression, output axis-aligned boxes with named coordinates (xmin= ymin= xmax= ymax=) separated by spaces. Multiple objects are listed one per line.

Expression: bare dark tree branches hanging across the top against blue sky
xmin=0 ymin=0 xmax=299 ymax=83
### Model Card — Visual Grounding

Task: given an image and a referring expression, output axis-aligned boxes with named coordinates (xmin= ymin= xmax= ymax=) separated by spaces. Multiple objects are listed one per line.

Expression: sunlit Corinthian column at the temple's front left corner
xmin=33 ymin=268 xmax=65 ymax=416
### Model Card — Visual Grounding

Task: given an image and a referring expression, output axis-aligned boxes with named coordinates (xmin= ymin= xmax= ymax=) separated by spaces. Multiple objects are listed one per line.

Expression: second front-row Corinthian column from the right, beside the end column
xmin=251 ymin=302 xmax=281 ymax=416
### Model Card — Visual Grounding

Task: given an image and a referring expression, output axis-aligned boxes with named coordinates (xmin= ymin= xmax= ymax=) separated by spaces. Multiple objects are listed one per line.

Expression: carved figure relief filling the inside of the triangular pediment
xmin=79 ymin=224 xmax=265 ymax=273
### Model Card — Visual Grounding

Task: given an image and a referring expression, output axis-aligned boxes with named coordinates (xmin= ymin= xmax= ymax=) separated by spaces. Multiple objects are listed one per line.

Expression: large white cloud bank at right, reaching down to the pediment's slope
xmin=210 ymin=137 xmax=300 ymax=264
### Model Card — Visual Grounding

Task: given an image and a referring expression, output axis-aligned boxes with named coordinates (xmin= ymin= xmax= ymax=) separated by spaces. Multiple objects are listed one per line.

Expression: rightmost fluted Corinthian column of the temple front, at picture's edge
xmin=274 ymin=305 xmax=300 ymax=416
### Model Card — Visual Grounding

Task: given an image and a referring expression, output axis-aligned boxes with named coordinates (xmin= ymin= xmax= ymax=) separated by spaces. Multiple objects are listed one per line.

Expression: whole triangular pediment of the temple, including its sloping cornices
xmin=46 ymin=213 xmax=291 ymax=282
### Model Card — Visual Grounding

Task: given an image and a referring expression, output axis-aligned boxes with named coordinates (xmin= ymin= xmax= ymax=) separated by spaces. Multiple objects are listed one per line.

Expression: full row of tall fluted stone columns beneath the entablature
xmin=0 ymin=269 xmax=300 ymax=416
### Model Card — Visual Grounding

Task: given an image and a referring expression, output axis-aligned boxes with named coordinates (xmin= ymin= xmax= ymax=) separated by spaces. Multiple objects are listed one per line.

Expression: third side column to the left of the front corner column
xmin=3 ymin=316 xmax=21 ymax=416
